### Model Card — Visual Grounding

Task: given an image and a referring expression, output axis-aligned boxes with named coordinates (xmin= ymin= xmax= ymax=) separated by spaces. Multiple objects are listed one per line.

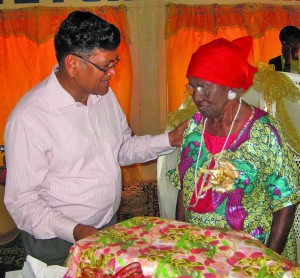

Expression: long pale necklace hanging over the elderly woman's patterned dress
xmin=189 ymin=98 xmax=242 ymax=207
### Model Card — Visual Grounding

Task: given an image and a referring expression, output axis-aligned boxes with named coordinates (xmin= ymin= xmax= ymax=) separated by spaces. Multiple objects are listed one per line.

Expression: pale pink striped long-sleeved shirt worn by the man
xmin=5 ymin=68 xmax=172 ymax=242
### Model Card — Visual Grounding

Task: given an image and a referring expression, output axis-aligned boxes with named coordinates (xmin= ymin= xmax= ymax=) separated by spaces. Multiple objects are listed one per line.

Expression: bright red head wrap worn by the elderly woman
xmin=187 ymin=36 xmax=257 ymax=90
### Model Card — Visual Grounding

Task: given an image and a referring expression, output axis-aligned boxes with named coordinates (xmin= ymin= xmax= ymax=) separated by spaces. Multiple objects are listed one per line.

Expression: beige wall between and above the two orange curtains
xmin=0 ymin=0 xmax=300 ymax=180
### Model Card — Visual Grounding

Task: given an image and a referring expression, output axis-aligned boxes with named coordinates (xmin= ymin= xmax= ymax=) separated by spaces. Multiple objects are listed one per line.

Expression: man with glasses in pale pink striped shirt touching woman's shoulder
xmin=5 ymin=11 xmax=186 ymax=265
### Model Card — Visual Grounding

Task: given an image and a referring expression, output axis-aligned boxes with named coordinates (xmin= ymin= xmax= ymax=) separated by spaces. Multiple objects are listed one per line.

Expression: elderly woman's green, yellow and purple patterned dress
xmin=169 ymin=107 xmax=300 ymax=261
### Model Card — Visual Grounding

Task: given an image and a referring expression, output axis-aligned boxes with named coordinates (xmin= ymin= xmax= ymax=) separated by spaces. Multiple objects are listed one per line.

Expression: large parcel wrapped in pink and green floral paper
xmin=65 ymin=217 xmax=300 ymax=278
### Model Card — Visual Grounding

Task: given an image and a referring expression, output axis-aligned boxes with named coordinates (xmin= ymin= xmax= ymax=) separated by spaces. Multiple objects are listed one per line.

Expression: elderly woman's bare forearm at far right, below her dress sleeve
xmin=267 ymin=205 xmax=296 ymax=254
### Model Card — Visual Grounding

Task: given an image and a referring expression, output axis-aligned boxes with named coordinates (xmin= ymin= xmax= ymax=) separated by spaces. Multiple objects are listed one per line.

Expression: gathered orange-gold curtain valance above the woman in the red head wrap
xmin=165 ymin=3 xmax=300 ymax=38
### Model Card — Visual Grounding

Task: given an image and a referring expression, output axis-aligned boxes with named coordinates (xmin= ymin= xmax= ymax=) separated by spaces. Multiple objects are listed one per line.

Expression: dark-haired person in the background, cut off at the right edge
xmin=269 ymin=26 xmax=300 ymax=73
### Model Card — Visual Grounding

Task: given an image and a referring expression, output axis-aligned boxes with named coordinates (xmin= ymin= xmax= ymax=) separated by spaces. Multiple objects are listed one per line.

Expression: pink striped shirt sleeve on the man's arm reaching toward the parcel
xmin=4 ymin=116 xmax=78 ymax=242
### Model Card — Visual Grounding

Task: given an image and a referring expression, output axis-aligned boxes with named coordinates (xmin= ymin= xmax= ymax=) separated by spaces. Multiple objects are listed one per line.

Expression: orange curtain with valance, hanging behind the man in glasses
xmin=0 ymin=5 xmax=140 ymax=182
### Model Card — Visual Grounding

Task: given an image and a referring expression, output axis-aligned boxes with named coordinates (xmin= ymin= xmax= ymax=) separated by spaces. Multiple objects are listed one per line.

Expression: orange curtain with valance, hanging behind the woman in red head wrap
xmin=165 ymin=4 xmax=300 ymax=111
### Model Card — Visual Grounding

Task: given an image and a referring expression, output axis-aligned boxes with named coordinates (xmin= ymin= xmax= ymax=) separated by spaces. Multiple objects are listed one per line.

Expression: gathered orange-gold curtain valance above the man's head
xmin=0 ymin=5 xmax=130 ymax=44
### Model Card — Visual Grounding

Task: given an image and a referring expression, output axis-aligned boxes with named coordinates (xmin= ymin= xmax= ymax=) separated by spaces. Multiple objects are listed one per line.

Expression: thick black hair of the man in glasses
xmin=54 ymin=11 xmax=120 ymax=66
